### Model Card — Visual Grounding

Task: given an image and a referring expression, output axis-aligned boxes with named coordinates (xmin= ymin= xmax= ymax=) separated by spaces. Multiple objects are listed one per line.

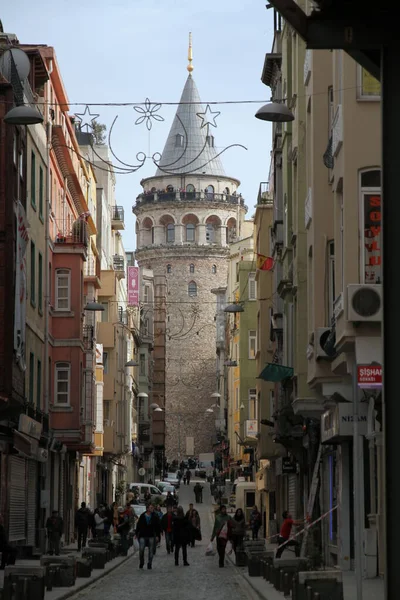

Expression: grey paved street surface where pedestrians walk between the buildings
xmin=74 ymin=481 xmax=258 ymax=600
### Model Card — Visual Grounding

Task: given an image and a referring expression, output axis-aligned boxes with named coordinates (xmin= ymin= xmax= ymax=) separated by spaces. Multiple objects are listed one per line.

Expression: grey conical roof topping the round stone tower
xmin=156 ymin=74 xmax=226 ymax=177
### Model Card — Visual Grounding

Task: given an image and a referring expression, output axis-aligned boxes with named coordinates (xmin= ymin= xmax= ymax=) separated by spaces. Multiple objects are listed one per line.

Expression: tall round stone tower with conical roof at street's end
xmin=133 ymin=37 xmax=246 ymax=462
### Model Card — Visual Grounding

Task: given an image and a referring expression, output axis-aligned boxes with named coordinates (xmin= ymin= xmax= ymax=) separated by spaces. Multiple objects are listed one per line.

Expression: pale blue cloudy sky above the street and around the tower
xmin=0 ymin=0 xmax=273 ymax=250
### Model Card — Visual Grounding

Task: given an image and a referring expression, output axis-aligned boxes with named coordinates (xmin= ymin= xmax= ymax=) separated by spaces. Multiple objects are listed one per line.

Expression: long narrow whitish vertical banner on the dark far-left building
xmin=14 ymin=202 xmax=29 ymax=371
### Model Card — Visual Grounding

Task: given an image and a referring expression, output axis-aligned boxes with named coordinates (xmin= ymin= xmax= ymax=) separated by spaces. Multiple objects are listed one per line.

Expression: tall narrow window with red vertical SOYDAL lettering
xmin=360 ymin=169 xmax=382 ymax=283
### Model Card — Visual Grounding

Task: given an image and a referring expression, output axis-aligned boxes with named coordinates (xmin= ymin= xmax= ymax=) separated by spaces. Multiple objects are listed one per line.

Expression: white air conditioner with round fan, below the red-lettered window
xmin=347 ymin=283 xmax=383 ymax=323
